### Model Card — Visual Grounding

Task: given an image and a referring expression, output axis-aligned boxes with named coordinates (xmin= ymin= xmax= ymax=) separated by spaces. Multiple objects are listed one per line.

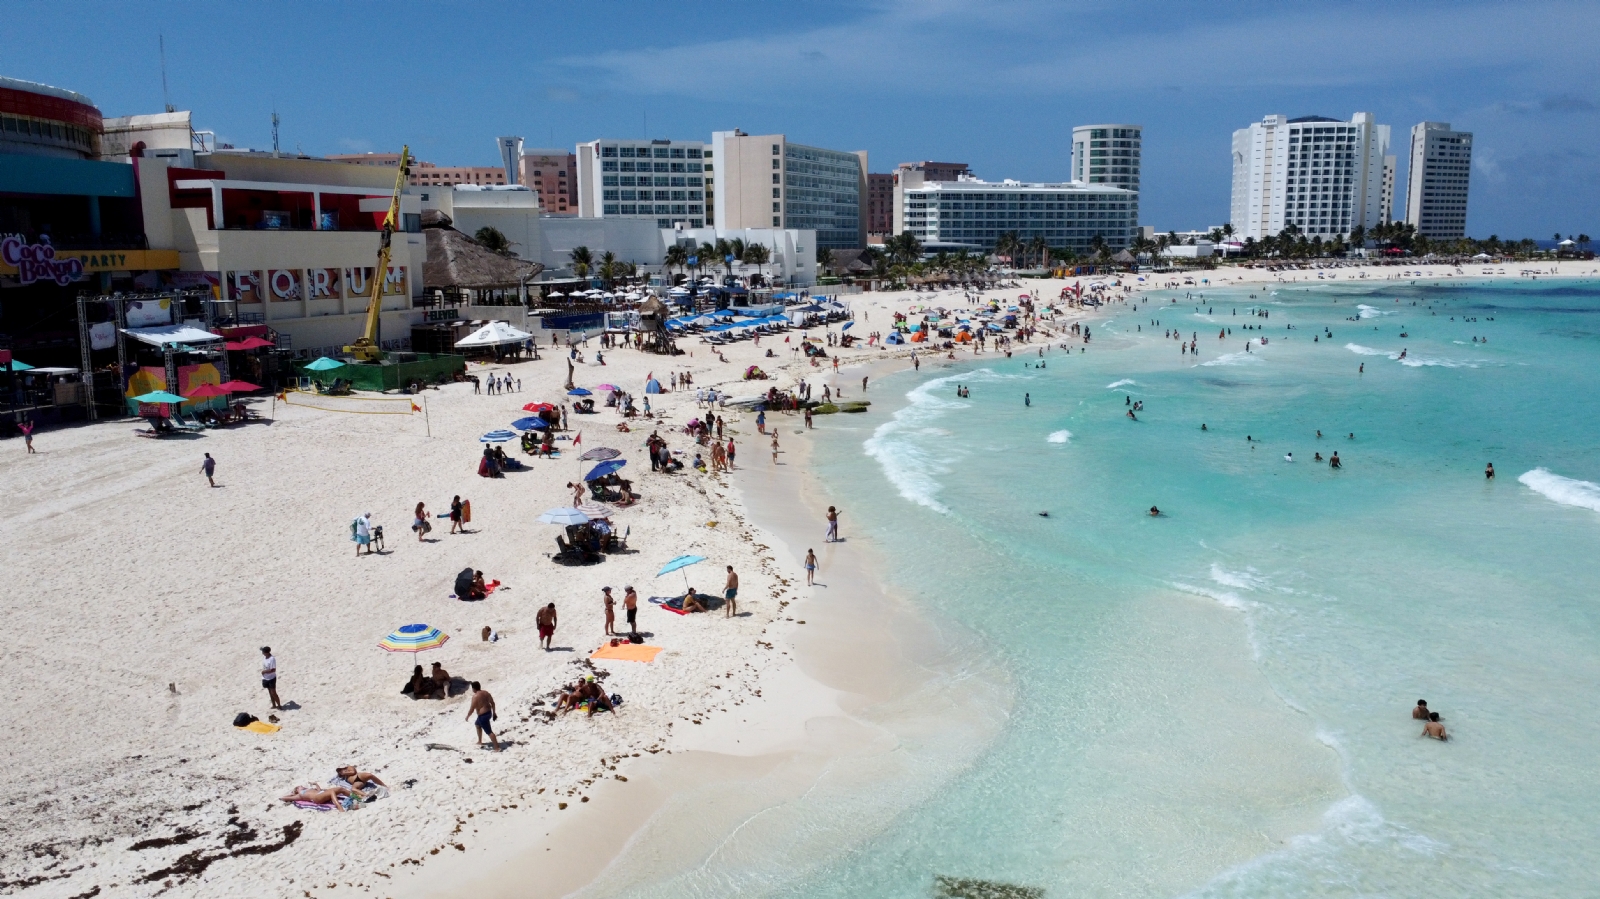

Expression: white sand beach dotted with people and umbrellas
xmin=0 ymin=255 xmax=1595 ymax=897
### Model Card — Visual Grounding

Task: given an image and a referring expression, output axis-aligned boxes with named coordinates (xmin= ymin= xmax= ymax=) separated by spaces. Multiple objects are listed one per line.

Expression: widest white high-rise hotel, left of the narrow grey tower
xmin=1230 ymin=112 xmax=1394 ymax=240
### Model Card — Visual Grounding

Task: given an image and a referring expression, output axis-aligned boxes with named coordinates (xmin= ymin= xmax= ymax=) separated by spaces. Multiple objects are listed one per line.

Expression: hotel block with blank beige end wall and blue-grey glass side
xmin=710 ymin=130 xmax=867 ymax=250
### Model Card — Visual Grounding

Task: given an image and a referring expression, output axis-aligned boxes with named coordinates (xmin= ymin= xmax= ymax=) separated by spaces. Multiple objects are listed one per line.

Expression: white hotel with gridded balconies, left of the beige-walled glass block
xmin=578 ymin=141 xmax=706 ymax=227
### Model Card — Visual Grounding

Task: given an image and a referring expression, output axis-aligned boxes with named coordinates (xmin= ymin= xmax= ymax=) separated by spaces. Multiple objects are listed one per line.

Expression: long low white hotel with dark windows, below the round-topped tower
xmin=894 ymin=174 xmax=1139 ymax=253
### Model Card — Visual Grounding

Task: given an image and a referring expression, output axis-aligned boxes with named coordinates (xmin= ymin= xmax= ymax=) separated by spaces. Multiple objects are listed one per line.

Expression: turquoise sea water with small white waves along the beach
xmin=773 ymin=282 xmax=1600 ymax=897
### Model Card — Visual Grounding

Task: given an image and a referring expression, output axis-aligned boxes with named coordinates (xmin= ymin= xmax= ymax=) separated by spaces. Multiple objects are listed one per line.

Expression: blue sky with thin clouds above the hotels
xmin=12 ymin=0 xmax=1600 ymax=238
